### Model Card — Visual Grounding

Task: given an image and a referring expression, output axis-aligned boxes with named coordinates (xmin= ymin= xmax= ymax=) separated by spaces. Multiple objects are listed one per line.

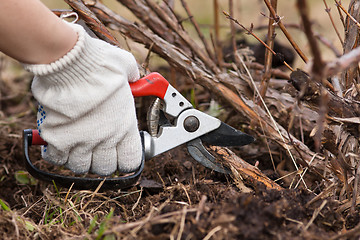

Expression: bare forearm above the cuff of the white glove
xmin=0 ymin=0 xmax=77 ymax=64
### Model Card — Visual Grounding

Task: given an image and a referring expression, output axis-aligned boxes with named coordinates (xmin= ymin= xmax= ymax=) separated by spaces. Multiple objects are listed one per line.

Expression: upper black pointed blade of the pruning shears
xmin=200 ymin=122 xmax=255 ymax=147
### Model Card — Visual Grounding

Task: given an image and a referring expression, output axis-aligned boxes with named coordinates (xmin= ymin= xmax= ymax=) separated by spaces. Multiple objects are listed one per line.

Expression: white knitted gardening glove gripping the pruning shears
xmin=24 ymin=24 xmax=142 ymax=175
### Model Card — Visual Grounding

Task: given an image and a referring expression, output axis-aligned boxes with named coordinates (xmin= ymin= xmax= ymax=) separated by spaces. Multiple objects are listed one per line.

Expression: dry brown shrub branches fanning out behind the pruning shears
xmin=67 ymin=0 xmax=360 ymax=195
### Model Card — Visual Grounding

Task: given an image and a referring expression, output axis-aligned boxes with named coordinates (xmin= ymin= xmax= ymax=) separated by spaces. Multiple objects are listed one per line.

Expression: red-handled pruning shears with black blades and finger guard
xmin=23 ymin=72 xmax=255 ymax=189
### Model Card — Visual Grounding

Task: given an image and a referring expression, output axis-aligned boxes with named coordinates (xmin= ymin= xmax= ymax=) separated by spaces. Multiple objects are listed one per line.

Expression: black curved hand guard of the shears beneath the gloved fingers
xmin=23 ymin=129 xmax=145 ymax=189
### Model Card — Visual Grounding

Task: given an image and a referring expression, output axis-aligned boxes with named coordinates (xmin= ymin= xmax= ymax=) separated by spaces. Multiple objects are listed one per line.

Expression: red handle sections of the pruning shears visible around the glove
xmin=31 ymin=72 xmax=169 ymax=145
